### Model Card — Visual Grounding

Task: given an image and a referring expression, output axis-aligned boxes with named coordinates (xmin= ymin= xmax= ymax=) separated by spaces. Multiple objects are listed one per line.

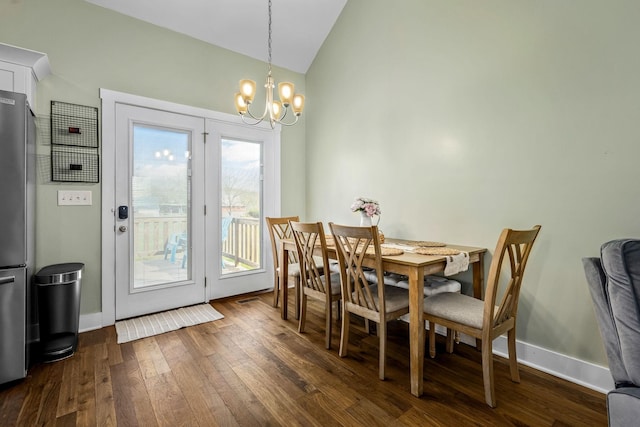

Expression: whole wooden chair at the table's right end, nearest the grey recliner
xmin=424 ymin=225 xmax=541 ymax=408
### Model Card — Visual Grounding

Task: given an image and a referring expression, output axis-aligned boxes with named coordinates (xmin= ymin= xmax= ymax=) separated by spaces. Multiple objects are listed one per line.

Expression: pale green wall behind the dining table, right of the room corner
xmin=306 ymin=0 xmax=640 ymax=364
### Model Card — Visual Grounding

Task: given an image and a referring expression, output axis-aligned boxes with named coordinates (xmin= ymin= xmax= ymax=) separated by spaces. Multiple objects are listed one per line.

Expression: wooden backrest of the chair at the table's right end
xmin=483 ymin=225 xmax=541 ymax=330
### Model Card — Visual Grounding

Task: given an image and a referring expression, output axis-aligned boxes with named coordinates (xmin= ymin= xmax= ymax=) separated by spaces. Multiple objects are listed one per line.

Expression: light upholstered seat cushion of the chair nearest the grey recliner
xmin=424 ymin=292 xmax=484 ymax=329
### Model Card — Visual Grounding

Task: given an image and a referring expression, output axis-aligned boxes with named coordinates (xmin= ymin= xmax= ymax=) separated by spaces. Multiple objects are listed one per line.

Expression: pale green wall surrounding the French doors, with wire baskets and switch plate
xmin=0 ymin=0 xmax=305 ymax=314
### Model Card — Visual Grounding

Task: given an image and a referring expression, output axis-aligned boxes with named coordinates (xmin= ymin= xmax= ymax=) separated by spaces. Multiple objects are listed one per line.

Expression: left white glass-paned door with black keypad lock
xmin=114 ymin=104 xmax=206 ymax=319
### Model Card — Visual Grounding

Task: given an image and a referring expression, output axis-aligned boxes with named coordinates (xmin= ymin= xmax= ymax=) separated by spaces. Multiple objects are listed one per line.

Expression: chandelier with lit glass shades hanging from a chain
xmin=235 ymin=0 xmax=304 ymax=129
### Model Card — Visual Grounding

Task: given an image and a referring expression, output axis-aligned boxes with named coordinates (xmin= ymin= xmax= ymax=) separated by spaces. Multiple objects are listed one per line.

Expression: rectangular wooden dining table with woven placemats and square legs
xmin=279 ymin=238 xmax=487 ymax=397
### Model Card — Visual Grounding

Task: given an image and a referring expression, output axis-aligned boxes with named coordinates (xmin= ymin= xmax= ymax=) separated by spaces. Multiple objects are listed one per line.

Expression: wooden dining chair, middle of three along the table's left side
xmin=290 ymin=221 xmax=341 ymax=349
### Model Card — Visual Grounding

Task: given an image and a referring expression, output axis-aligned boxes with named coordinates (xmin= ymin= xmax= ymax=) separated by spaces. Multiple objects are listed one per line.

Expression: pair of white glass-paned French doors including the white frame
xmin=101 ymin=89 xmax=280 ymax=325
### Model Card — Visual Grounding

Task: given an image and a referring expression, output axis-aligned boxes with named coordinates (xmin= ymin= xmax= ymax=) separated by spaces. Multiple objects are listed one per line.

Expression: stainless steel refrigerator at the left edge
xmin=0 ymin=91 xmax=36 ymax=384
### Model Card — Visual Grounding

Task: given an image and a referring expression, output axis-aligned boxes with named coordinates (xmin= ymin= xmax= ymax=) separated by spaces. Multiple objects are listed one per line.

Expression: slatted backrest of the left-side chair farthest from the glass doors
xmin=329 ymin=222 xmax=385 ymax=313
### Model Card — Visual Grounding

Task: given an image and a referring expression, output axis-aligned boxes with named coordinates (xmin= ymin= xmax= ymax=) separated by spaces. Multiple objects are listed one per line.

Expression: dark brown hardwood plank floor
xmin=0 ymin=294 xmax=607 ymax=427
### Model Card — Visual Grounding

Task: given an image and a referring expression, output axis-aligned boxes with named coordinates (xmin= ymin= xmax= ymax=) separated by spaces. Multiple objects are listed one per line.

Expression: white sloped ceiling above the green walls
xmin=86 ymin=0 xmax=347 ymax=74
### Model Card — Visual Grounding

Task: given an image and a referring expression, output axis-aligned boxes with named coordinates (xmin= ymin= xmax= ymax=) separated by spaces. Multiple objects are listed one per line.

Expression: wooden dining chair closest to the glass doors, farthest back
xmin=265 ymin=216 xmax=301 ymax=319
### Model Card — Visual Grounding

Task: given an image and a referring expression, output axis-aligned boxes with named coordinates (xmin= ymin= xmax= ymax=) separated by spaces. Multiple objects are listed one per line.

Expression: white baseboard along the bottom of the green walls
xmin=79 ymin=313 xmax=615 ymax=393
